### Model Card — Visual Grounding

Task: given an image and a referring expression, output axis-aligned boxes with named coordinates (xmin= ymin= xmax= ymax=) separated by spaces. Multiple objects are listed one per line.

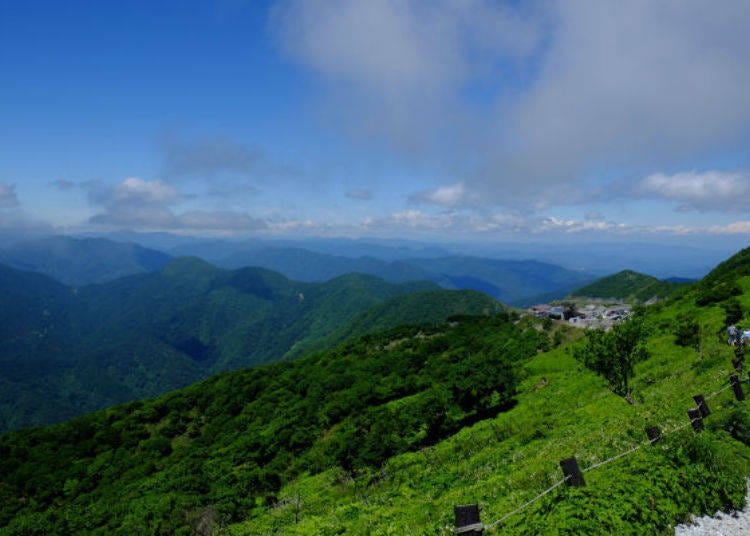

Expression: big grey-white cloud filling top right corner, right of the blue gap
xmin=484 ymin=0 xmax=750 ymax=202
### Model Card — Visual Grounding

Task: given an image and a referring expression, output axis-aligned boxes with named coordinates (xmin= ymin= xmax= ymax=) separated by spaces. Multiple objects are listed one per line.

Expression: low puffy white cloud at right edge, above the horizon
xmin=636 ymin=171 xmax=750 ymax=211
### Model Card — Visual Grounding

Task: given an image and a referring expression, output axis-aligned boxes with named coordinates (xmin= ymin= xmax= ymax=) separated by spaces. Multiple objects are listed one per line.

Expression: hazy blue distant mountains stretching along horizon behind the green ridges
xmin=0 ymin=236 xmax=594 ymax=306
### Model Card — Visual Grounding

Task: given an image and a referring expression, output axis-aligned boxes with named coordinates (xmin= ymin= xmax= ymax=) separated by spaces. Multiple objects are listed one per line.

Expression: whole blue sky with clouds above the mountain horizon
xmin=0 ymin=0 xmax=750 ymax=246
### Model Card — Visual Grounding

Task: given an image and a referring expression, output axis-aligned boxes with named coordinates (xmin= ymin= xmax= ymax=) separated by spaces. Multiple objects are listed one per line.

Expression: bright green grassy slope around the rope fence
xmin=229 ymin=271 xmax=750 ymax=535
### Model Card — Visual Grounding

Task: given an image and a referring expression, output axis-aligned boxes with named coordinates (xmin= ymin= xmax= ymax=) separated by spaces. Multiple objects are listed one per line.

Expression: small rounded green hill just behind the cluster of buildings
xmin=571 ymin=270 xmax=682 ymax=302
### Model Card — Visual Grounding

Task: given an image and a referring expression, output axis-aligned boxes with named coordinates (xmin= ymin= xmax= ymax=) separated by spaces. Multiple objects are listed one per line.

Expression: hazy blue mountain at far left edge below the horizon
xmin=0 ymin=236 xmax=171 ymax=286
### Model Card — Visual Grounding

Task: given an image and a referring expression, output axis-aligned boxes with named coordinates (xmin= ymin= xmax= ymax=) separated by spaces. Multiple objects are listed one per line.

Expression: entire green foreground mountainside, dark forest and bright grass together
xmin=0 ymin=250 xmax=750 ymax=535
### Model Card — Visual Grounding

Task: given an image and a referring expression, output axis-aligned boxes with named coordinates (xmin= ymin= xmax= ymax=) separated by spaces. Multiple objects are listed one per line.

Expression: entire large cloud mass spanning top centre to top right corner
xmin=271 ymin=0 xmax=750 ymax=209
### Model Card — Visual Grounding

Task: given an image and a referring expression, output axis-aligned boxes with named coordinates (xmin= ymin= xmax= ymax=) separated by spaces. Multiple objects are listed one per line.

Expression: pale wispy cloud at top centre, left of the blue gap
xmin=271 ymin=0 xmax=540 ymax=153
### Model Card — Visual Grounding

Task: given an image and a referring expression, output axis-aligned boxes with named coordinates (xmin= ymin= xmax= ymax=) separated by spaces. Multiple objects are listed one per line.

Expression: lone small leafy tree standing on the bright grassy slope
xmin=573 ymin=318 xmax=649 ymax=398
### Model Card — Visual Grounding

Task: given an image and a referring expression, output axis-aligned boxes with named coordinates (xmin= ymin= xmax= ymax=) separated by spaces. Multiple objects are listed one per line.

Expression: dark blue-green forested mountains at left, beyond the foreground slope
xmin=0 ymin=258 xmax=506 ymax=430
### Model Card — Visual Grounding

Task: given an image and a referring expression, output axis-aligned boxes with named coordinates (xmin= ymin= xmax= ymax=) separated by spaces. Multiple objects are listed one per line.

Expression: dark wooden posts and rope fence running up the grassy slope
xmin=453 ymin=367 xmax=750 ymax=535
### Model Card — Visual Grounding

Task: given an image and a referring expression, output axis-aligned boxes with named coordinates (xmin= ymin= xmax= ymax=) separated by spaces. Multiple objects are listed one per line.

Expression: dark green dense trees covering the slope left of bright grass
xmin=0 ymin=315 xmax=547 ymax=534
